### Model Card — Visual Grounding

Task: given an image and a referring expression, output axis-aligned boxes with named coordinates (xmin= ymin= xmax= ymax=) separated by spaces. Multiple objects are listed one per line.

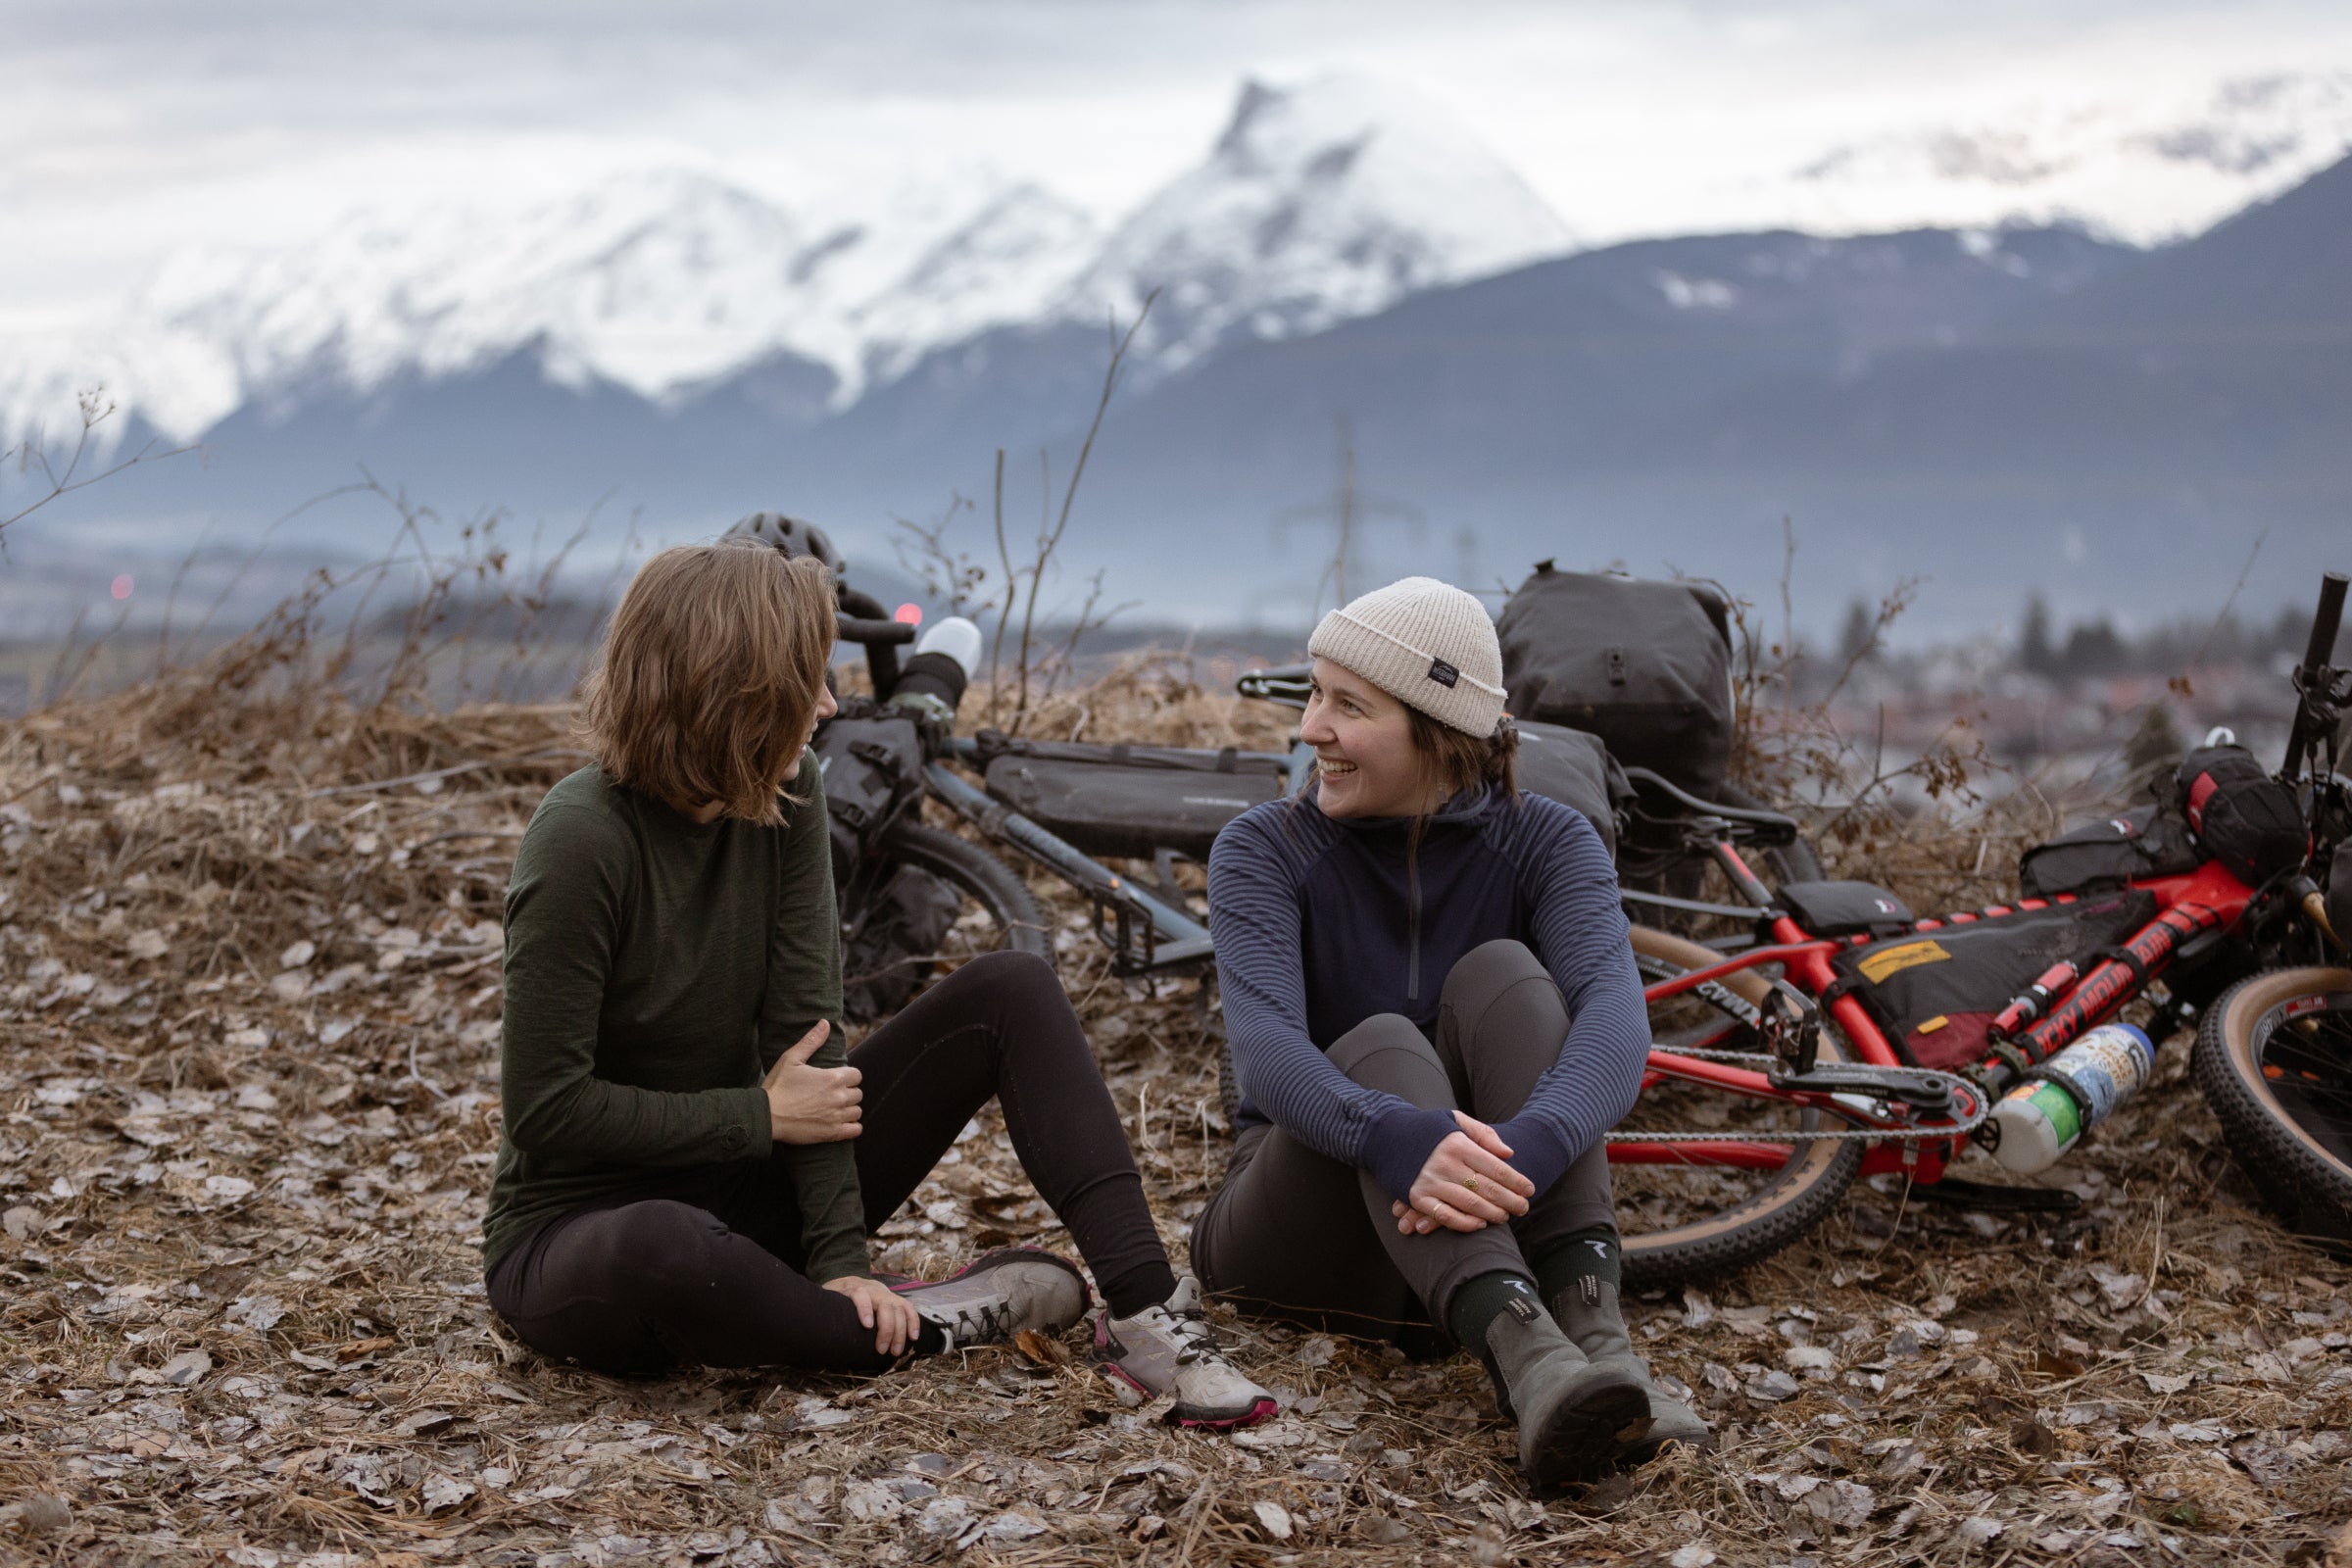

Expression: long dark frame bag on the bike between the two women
xmin=981 ymin=736 xmax=1282 ymax=860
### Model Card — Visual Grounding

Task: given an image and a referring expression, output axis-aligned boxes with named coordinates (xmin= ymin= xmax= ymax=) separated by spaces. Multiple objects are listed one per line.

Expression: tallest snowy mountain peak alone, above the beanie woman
xmin=1058 ymin=75 xmax=1571 ymax=369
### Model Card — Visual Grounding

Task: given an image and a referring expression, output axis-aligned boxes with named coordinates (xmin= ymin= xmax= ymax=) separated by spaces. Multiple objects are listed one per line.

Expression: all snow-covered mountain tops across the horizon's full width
xmin=18 ymin=73 xmax=2352 ymax=461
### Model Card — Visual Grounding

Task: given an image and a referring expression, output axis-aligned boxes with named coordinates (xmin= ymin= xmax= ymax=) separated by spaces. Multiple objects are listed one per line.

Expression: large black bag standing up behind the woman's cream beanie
xmin=1495 ymin=562 xmax=1731 ymax=800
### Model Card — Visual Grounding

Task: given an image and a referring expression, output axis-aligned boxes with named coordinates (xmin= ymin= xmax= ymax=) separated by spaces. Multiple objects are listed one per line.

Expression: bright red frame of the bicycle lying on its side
xmin=1609 ymin=842 xmax=2253 ymax=1183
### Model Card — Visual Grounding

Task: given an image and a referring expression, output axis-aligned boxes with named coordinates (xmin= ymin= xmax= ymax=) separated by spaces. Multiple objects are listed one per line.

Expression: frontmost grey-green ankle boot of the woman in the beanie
xmin=1487 ymin=1298 xmax=1648 ymax=1491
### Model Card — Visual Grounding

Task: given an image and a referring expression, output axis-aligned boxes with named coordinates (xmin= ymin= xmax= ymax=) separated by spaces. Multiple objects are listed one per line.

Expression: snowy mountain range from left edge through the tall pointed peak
xmin=0 ymin=77 xmax=1566 ymax=451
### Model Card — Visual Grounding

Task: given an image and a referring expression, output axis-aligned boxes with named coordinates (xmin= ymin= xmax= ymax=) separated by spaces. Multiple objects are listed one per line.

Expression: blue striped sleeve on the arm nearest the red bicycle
xmin=1495 ymin=795 xmax=1648 ymax=1192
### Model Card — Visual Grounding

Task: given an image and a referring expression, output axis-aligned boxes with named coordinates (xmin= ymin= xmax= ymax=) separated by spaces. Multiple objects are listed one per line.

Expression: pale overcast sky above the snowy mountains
xmin=0 ymin=0 xmax=2352 ymax=331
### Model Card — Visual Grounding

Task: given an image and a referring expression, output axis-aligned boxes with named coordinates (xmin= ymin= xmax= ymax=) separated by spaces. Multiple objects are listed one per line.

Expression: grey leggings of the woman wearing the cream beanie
xmin=1193 ymin=941 xmax=1613 ymax=1354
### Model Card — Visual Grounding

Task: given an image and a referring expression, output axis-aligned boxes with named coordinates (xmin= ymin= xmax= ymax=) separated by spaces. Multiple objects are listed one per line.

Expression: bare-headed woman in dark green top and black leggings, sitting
xmin=482 ymin=543 xmax=1275 ymax=1425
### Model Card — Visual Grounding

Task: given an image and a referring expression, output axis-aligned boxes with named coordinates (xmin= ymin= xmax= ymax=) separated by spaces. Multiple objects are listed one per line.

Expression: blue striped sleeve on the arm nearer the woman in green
xmin=1209 ymin=802 xmax=1453 ymax=1199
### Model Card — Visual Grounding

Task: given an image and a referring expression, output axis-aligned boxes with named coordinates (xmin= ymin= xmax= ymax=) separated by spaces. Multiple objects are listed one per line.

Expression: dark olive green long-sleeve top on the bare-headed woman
xmin=482 ymin=755 xmax=868 ymax=1281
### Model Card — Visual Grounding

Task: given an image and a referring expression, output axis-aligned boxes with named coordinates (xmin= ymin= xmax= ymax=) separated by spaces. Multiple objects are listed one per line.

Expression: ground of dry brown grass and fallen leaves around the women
xmin=0 ymin=659 xmax=2352 ymax=1568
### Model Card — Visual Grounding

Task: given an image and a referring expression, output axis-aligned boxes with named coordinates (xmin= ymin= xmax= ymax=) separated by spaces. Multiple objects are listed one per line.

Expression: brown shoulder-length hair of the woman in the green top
xmin=581 ymin=543 xmax=833 ymax=827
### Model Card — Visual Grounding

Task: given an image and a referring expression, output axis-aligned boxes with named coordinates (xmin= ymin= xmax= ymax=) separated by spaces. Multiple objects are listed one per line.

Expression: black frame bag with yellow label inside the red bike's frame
xmin=1830 ymin=889 xmax=2157 ymax=1069
